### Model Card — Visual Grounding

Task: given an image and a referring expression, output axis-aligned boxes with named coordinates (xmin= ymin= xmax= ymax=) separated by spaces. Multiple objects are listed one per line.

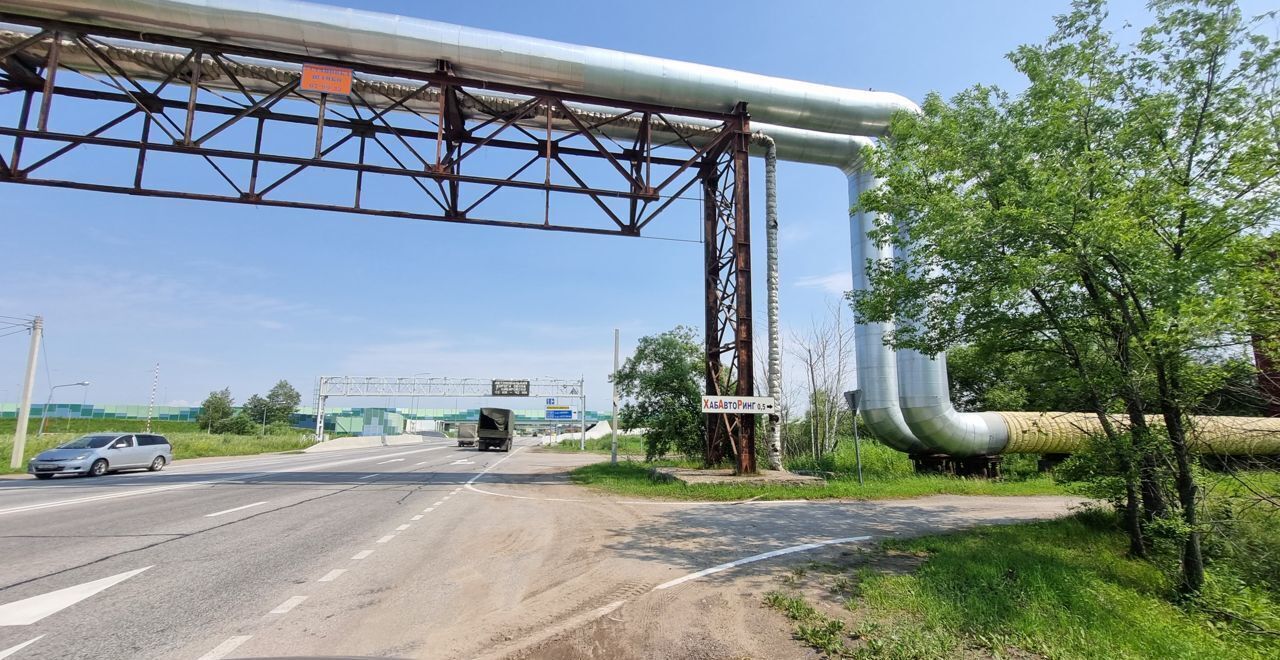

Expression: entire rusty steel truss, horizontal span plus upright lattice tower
xmin=0 ymin=18 xmax=755 ymax=472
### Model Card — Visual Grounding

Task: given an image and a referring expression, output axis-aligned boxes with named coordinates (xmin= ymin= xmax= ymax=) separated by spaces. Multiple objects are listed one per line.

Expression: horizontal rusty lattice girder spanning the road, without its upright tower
xmin=0 ymin=13 xmax=731 ymax=235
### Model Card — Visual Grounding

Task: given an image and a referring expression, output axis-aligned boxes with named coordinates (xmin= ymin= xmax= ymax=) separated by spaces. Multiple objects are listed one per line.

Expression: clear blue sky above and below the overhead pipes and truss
xmin=0 ymin=0 xmax=1262 ymax=408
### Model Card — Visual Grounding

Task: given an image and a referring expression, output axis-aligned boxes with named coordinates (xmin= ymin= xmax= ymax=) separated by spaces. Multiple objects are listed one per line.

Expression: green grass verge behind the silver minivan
xmin=0 ymin=420 xmax=311 ymax=473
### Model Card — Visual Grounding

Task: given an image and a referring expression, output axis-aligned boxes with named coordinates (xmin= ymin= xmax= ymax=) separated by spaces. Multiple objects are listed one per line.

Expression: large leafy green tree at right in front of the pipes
xmin=854 ymin=0 xmax=1280 ymax=593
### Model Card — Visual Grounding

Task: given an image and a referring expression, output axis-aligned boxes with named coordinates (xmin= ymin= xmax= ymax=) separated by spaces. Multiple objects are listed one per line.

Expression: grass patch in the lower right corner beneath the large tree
xmin=849 ymin=512 xmax=1280 ymax=659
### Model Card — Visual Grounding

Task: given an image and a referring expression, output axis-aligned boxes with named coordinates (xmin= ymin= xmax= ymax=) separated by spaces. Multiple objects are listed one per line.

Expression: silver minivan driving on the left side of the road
xmin=27 ymin=434 xmax=173 ymax=478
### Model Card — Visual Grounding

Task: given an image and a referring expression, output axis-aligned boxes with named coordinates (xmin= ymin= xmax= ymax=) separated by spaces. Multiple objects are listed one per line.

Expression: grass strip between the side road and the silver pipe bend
xmin=570 ymin=460 xmax=1065 ymax=501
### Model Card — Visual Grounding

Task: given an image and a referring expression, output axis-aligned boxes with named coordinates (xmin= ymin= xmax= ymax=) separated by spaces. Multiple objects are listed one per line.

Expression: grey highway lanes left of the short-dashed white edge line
xmin=0 ymin=444 xmax=488 ymax=657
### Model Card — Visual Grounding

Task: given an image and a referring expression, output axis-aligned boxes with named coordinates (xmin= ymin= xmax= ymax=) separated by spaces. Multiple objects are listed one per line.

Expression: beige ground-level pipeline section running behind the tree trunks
xmin=993 ymin=412 xmax=1280 ymax=455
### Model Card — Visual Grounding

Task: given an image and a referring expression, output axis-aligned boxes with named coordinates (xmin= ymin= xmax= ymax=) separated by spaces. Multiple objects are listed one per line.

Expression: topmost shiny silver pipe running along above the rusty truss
xmin=5 ymin=0 xmax=915 ymax=136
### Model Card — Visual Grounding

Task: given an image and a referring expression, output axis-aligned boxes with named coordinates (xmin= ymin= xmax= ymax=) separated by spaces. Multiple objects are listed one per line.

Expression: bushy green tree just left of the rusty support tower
xmin=617 ymin=326 xmax=704 ymax=460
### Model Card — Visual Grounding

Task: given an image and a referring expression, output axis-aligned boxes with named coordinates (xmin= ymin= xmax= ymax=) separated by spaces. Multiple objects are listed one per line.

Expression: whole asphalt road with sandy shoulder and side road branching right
xmin=0 ymin=441 xmax=1070 ymax=660
